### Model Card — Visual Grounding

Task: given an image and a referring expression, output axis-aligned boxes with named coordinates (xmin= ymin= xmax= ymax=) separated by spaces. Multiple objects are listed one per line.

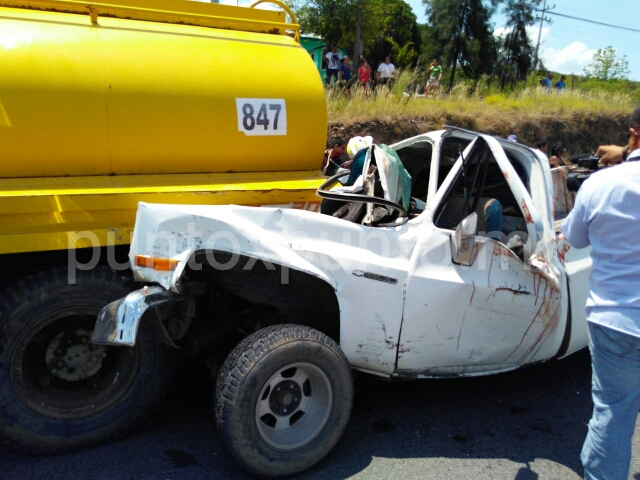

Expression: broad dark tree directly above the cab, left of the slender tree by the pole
xmin=423 ymin=0 xmax=495 ymax=90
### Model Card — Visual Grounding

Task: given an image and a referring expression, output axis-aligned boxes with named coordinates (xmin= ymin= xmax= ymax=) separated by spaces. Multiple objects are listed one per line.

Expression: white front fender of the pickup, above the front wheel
xmin=130 ymin=203 xmax=416 ymax=374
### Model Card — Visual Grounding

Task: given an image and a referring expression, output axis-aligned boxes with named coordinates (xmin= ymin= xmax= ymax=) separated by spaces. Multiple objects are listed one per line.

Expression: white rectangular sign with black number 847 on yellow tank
xmin=236 ymin=98 xmax=287 ymax=136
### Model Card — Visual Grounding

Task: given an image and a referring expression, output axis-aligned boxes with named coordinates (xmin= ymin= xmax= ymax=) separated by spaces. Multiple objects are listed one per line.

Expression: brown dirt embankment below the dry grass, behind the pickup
xmin=327 ymin=113 xmax=629 ymax=158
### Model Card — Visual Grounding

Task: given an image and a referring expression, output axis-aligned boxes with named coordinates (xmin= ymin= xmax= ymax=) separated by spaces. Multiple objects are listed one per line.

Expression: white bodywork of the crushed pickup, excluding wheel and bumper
xmin=124 ymin=132 xmax=590 ymax=377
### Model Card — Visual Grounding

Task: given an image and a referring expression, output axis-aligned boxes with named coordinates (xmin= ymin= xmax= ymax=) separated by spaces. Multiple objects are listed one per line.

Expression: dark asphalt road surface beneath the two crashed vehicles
xmin=0 ymin=352 xmax=640 ymax=480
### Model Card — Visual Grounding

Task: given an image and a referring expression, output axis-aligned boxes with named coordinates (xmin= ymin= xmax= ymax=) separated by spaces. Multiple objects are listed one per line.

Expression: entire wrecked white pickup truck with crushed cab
xmin=93 ymin=129 xmax=591 ymax=476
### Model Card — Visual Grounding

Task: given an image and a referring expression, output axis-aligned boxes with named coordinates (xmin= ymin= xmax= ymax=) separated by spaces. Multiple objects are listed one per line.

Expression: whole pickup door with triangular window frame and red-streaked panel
xmin=395 ymin=136 xmax=565 ymax=376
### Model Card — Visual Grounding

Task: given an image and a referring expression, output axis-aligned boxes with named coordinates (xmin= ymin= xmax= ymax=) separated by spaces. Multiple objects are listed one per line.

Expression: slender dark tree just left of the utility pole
xmin=500 ymin=0 xmax=541 ymax=89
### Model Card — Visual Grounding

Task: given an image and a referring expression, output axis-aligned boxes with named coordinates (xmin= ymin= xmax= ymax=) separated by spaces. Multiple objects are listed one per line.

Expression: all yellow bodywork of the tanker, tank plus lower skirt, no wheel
xmin=0 ymin=0 xmax=327 ymax=255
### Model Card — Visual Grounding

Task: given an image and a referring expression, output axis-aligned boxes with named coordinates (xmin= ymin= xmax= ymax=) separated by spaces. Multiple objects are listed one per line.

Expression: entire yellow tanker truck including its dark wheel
xmin=0 ymin=0 xmax=326 ymax=452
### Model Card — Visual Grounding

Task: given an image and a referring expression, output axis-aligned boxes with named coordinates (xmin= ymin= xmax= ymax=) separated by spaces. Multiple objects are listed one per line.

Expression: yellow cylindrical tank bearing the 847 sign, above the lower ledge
xmin=0 ymin=0 xmax=327 ymax=178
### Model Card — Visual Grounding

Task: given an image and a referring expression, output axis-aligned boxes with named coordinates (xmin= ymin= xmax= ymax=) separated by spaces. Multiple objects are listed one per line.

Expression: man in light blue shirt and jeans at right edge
xmin=562 ymin=106 xmax=640 ymax=480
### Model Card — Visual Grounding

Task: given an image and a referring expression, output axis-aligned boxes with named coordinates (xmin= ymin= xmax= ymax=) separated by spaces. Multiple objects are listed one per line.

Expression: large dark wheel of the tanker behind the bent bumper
xmin=0 ymin=267 xmax=176 ymax=453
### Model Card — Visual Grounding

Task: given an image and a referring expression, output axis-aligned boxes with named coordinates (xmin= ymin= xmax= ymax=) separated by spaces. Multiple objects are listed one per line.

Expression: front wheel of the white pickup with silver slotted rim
xmin=214 ymin=325 xmax=353 ymax=476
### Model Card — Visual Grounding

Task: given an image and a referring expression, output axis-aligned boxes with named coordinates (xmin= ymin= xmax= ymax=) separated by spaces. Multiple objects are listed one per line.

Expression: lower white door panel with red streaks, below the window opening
xmin=397 ymin=230 xmax=565 ymax=376
